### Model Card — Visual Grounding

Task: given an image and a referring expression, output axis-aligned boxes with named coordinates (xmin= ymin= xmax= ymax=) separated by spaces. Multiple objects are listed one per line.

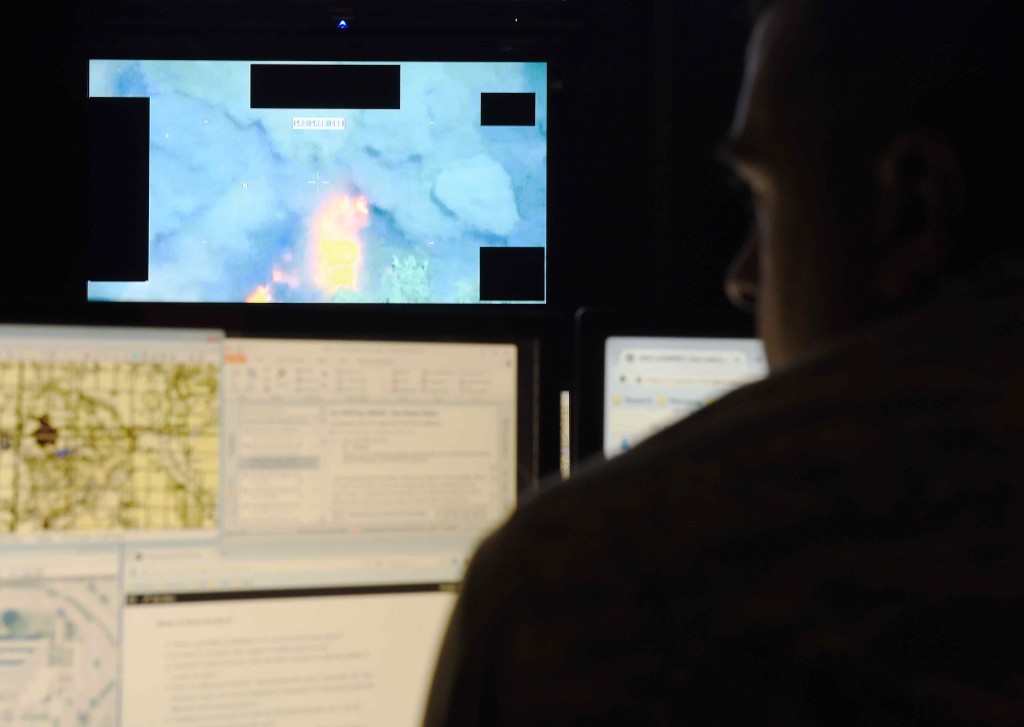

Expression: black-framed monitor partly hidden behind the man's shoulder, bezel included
xmin=571 ymin=308 xmax=767 ymax=462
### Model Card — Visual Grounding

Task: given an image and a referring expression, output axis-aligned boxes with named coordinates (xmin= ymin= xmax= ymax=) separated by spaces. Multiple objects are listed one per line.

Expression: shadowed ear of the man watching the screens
xmin=876 ymin=133 xmax=964 ymax=304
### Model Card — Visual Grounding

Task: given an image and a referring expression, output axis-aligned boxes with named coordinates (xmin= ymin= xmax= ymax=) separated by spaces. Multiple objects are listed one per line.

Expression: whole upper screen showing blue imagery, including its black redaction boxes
xmin=88 ymin=57 xmax=548 ymax=304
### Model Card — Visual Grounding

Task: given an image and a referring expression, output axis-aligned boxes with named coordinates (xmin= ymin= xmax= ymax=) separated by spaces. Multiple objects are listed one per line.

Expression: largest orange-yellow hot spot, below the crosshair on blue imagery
xmin=309 ymin=195 xmax=370 ymax=294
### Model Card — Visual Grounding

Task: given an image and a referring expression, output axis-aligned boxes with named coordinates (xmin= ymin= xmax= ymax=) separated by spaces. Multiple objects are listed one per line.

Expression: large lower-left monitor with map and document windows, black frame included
xmin=0 ymin=311 xmax=539 ymax=727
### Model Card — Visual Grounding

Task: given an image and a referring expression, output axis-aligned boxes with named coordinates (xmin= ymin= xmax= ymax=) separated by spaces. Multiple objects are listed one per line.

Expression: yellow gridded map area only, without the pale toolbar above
xmin=0 ymin=360 xmax=220 ymax=533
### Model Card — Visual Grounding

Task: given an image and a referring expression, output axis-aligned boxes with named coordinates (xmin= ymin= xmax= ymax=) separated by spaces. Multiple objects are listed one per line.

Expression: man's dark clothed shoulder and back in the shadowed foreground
xmin=442 ymin=264 xmax=1024 ymax=724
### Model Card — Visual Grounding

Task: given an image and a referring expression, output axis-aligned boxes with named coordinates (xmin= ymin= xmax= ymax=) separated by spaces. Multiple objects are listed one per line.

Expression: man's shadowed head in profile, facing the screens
xmin=723 ymin=0 xmax=1024 ymax=368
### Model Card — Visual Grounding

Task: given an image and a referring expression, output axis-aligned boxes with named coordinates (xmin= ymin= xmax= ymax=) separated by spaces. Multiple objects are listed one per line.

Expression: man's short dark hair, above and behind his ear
xmin=751 ymin=0 xmax=1024 ymax=268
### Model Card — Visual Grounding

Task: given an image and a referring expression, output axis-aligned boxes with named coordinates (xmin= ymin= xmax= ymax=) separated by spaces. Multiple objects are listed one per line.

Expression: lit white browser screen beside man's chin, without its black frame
xmin=603 ymin=336 xmax=768 ymax=457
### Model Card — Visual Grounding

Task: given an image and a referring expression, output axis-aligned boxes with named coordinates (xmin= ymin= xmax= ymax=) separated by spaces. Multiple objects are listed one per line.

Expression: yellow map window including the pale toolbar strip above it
xmin=0 ymin=326 xmax=223 ymax=544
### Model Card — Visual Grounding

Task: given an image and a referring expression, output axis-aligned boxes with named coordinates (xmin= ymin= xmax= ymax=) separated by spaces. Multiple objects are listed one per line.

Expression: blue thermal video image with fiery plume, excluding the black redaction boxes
xmin=88 ymin=59 xmax=548 ymax=303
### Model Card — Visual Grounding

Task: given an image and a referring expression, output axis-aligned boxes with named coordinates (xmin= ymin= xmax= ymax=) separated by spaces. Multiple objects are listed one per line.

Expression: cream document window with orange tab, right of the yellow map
xmin=222 ymin=338 xmax=518 ymax=537
